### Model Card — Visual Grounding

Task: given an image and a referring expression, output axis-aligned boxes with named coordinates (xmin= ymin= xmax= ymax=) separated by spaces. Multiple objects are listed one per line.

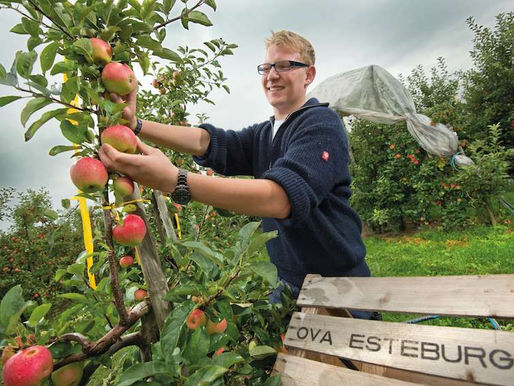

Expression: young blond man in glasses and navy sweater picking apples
xmin=100 ymin=31 xmax=370 ymax=318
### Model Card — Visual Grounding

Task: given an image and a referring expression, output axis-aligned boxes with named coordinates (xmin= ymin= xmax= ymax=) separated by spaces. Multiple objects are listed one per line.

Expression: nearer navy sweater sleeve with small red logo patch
xmin=263 ymin=109 xmax=350 ymax=224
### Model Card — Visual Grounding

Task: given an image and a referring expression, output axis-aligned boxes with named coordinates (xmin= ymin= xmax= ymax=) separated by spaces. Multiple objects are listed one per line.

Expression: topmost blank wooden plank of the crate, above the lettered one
xmin=297 ymin=275 xmax=514 ymax=318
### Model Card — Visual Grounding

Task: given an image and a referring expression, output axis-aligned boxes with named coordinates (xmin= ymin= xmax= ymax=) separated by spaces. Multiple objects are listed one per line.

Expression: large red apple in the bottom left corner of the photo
xmin=2 ymin=346 xmax=53 ymax=386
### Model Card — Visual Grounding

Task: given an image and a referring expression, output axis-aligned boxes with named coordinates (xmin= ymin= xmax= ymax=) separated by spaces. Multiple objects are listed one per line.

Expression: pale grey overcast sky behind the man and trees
xmin=0 ymin=0 xmax=508 ymax=225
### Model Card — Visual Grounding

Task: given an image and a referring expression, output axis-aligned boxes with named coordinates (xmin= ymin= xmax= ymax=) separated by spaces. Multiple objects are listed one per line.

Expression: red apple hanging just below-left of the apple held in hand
xmin=70 ymin=157 xmax=108 ymax=193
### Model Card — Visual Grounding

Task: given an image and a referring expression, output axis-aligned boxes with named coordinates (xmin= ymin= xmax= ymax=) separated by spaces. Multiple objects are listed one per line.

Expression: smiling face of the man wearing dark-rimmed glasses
xmin=261 ymin=45 xmax=315 ymax=119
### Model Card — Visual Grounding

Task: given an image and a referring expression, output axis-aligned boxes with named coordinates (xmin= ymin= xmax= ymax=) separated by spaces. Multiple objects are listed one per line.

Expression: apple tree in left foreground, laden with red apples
xmin=0 ymin=0 xmax=291 ymax=385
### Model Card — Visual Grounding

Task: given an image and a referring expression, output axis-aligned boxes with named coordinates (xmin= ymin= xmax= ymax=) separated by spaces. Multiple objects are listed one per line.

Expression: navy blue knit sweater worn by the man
xmin=195 ymin=98 xmax=370 ymax=287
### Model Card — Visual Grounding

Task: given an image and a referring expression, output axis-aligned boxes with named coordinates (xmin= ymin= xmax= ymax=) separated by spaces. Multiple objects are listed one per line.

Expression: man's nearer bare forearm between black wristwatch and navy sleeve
xmin=188 ymin=173 xmax=291 ymax=218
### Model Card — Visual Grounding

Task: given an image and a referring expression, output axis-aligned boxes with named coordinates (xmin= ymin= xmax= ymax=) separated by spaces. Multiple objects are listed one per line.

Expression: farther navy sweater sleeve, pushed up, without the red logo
xmin=193 ymin=123 xmax=257 ymax=176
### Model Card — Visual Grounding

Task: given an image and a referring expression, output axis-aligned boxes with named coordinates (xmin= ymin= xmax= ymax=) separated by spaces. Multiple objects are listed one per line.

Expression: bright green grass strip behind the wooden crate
xmin=365 ymin=226 xmax=514 ymax=331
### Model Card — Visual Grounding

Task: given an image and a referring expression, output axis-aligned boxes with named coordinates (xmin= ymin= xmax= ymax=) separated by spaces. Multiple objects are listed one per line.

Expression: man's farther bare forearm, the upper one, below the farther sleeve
xmin=139 ymin=121 xmax=210 ymax=156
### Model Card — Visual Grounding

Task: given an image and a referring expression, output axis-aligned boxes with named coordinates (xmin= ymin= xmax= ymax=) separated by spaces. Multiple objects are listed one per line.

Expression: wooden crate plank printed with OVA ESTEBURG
xmin=285 ymin=312 xmax=514 ymax=385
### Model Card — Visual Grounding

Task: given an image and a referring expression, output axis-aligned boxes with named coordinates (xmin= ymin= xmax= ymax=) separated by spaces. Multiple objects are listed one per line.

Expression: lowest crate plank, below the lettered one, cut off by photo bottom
xmin=274 ymin=354 xmax=418 ymax=386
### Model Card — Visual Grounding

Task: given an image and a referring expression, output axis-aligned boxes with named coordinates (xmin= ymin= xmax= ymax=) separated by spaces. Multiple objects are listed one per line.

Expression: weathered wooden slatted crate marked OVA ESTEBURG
xmin=275 ymin=275 xmax=514 ymax=385
